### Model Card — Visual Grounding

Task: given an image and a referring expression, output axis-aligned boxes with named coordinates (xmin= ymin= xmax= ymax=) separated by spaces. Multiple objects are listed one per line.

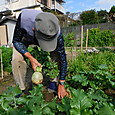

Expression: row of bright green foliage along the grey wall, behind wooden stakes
xmin=64 ymin=28 xmax=115 ymax=47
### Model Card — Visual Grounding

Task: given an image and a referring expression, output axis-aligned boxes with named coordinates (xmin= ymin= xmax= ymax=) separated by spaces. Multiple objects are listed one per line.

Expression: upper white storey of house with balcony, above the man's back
xmin=0 ymin=0 xmax=65 ymax=18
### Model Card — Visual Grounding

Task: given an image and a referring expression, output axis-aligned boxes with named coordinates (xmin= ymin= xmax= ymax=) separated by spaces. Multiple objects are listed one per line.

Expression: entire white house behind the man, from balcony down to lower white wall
xmin=0 ymin=0 xmax=65 ymax=46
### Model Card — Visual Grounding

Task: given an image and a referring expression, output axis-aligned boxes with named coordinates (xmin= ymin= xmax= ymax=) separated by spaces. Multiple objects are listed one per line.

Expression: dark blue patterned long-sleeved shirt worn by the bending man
xmin=13 ymin=14 xmax=67 ymax=80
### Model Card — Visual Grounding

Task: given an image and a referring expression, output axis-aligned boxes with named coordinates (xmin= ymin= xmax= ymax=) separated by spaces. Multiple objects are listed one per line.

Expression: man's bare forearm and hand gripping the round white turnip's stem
xmin=24 ymin=52 xmax=42 ymax=71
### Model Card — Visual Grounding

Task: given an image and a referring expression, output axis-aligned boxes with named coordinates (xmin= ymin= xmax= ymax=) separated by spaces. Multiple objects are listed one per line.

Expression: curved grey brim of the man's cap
xmin=36 ymin=32 xmax=57 ymax=52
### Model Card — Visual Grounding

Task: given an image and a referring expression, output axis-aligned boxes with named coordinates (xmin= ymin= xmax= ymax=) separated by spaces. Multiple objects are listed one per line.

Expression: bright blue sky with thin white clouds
xmin=63 ymin=0 xmax=115 ymax=13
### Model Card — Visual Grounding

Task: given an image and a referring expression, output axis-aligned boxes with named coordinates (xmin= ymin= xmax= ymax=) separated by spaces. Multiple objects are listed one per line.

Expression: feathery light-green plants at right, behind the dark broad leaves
xmin=68 ymin=51 xmax=115 ymax=76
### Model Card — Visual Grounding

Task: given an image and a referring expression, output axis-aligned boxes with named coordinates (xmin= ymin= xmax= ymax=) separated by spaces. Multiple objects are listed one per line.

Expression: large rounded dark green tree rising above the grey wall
xmin=80 ymin=10 xmax=98 ymax=25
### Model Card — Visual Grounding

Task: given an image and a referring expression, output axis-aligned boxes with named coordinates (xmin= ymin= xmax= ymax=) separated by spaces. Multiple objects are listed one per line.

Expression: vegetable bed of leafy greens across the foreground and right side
xmin=0 ymin=46 xmax=115 ymax=115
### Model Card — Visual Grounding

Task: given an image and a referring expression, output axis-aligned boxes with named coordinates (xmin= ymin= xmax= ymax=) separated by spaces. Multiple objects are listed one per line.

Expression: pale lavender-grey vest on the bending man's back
xmin=21 ymin=9 xmax=43 ymax=36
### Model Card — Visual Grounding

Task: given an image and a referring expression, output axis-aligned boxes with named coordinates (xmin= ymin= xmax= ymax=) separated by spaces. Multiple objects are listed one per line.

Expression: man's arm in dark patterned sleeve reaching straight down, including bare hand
xmin=57 ymin=33 xmax=67 ymax=98
